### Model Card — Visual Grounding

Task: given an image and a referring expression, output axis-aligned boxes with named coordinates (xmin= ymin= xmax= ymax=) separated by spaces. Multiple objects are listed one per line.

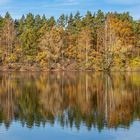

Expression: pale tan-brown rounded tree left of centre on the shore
xmin=38 ymin=28 xmax=64 ymax=68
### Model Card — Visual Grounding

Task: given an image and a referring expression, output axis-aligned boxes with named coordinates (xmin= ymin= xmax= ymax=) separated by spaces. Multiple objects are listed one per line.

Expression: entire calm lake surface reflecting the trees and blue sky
xmin=0 ymin=72 xmax=140 ymax=140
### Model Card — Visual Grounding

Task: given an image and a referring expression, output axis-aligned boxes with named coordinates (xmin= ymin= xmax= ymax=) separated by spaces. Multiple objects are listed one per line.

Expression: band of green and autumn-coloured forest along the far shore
xmin=0 ymin=10 xmax=140 ymax=71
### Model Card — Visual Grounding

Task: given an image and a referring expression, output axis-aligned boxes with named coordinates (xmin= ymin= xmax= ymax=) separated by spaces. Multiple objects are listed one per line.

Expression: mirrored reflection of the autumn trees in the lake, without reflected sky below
xmin=0 ymin=72 xmax=140 ymax=131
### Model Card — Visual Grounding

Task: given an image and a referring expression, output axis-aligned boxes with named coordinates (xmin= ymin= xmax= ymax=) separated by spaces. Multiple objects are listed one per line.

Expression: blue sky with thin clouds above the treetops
xmin=0 ymin=0 xmax=140 ymax=19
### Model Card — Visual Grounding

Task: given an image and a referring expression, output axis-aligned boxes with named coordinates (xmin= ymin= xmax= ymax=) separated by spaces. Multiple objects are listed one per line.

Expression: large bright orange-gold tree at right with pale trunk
xmin=98 ymin=13 xmax=134 ymax=69
